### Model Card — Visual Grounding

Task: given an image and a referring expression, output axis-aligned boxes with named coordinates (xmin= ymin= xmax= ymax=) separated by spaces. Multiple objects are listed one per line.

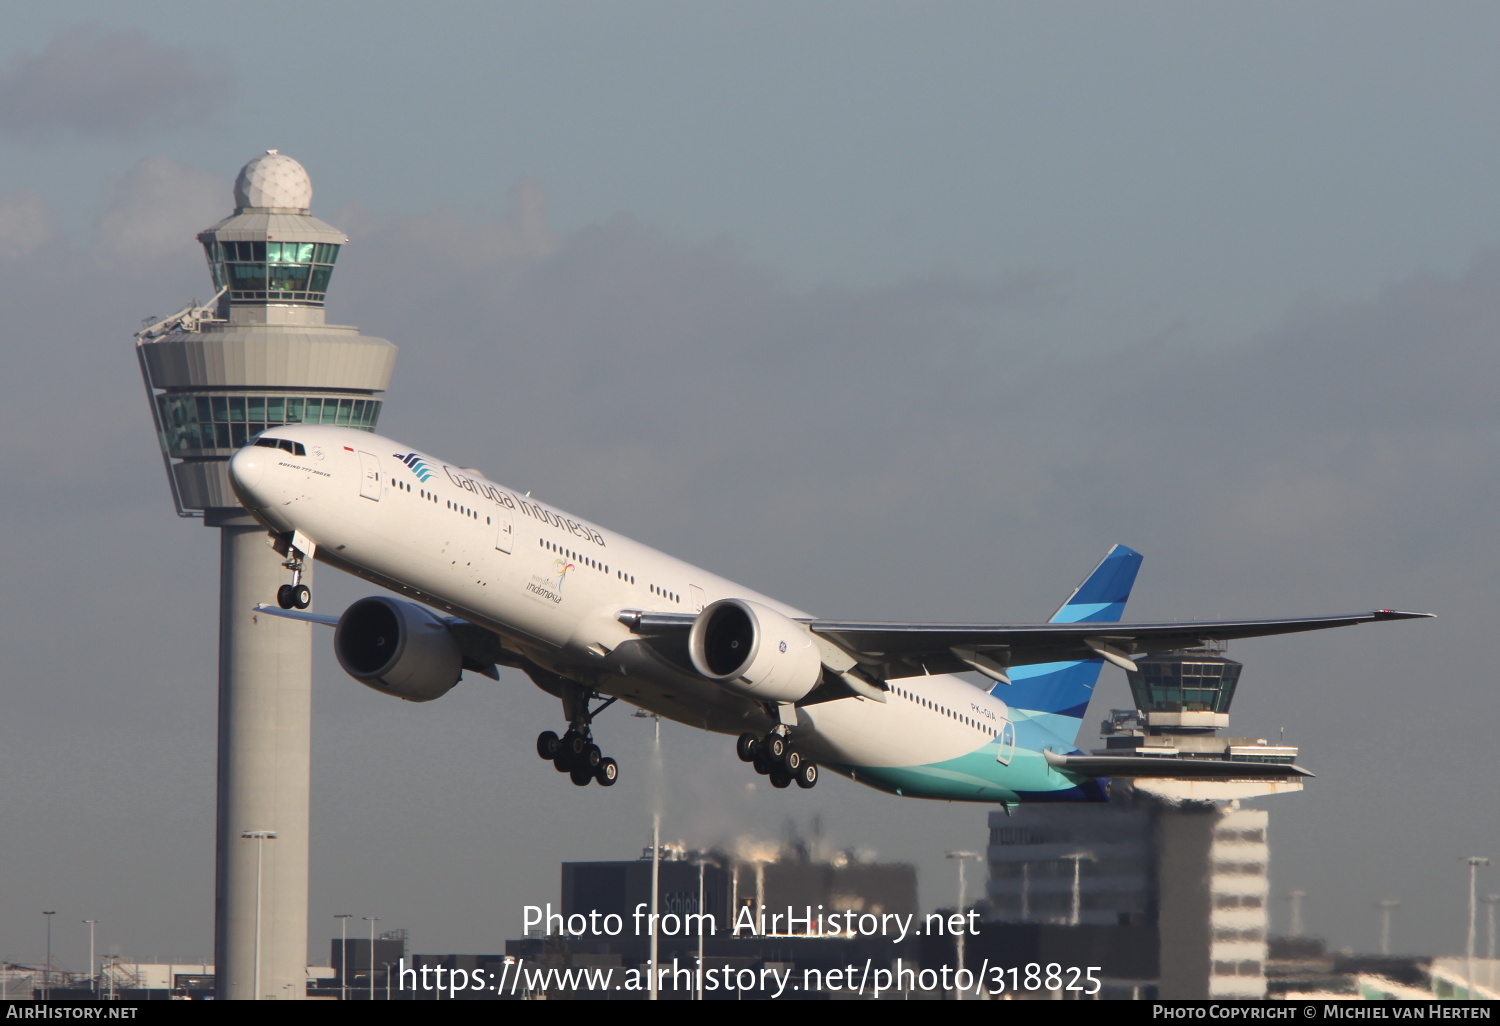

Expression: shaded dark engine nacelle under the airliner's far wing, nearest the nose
xmin=333 ymin=596 xmax=464 ymax=702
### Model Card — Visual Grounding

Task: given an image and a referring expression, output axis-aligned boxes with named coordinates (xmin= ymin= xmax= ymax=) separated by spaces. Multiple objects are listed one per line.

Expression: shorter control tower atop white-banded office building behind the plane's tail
xmin=971 ymin=647 xmax=1310 ymax=999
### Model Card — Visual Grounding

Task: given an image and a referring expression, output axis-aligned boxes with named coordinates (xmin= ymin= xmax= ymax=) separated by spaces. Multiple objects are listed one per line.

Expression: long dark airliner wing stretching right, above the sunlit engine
xmin=621 ymin=609 xmax=1433 ymax=681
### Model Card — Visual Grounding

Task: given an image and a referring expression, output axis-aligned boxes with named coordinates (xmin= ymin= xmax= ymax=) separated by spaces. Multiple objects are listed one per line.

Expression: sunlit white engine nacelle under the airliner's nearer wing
xmin=687 ymin=599 xmax=824 ymax=702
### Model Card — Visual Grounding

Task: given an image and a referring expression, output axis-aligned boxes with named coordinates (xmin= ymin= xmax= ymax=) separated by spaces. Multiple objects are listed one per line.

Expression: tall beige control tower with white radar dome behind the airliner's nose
xmin=135 ymin=150 xmax=396 ymax=1001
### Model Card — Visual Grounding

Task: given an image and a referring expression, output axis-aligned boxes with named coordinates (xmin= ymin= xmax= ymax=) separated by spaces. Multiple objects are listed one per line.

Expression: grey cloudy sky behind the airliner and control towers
xmin=0 ymin=3 xmax=1500 ymax=966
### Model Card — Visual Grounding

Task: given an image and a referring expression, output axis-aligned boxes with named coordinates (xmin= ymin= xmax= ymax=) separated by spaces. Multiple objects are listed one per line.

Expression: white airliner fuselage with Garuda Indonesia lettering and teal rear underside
xmin=231 ymin=426 xmax=1064 ymax=801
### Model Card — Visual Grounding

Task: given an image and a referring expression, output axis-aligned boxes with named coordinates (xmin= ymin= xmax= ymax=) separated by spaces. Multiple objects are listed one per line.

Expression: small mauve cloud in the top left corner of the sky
xmin=0 ymin=29 xmax=228 ymax=140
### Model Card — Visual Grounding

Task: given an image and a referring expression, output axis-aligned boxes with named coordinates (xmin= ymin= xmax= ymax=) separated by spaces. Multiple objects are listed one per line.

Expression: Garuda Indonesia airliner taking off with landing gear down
xmin=230 ymin=425 xmax=1428 ymax=809
